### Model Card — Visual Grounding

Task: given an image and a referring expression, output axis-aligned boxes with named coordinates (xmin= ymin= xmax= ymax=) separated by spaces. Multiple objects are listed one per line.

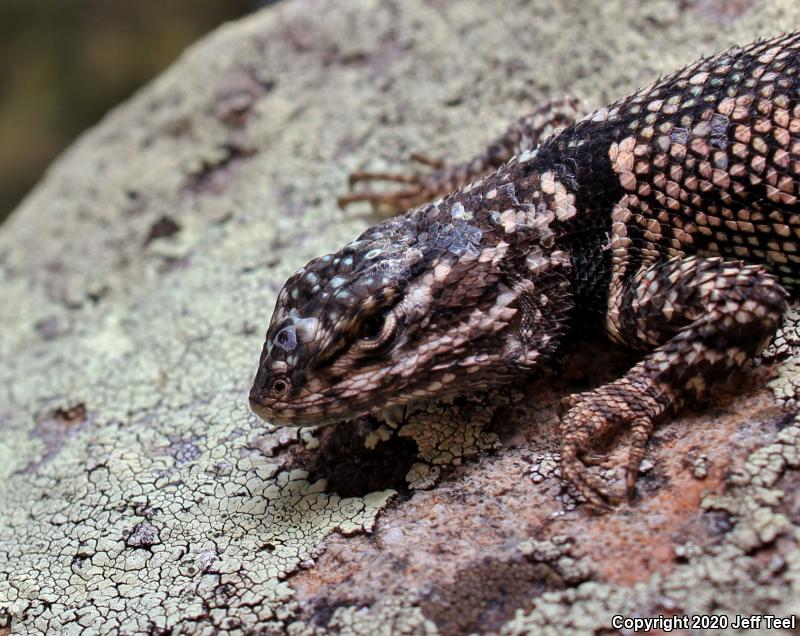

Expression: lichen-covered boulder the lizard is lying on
xmin=0 ymin=0 xmax=800 ymax=636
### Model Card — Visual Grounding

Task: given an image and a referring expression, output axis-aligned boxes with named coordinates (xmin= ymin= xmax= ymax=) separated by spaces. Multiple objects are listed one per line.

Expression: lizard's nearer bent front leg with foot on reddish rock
xmin=561 ymin=256 xmax=787 ymax=507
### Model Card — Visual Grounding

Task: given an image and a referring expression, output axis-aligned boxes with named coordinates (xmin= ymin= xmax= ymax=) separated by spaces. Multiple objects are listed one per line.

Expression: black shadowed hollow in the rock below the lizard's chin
xmin=290 ymin=418 xmax=417 ymax=497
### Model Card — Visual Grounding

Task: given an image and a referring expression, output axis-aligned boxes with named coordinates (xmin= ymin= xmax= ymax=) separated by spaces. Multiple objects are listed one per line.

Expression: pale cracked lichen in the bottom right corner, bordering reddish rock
xmin=500 ymin=410 xmax=800 ymax=636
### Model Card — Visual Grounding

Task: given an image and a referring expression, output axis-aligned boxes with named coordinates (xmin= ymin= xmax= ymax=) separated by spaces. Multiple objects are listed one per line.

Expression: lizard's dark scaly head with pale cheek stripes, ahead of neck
xmin=250 ymin=196 xmax=568 ymax=426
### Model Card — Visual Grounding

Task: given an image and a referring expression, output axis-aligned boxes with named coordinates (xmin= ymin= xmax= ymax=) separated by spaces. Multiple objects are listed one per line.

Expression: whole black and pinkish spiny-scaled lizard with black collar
xmin=249 ymin=32 xmax=800 ymax=509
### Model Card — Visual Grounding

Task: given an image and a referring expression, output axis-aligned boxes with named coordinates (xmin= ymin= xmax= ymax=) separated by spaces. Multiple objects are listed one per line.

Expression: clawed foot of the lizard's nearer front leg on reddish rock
xmin=561 ymin=380 xmax=661 ymax=510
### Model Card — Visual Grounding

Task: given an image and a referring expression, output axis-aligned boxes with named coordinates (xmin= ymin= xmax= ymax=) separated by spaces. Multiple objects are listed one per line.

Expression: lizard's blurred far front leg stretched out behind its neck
xmin=338 ymin=97 xmax=578 ymax=214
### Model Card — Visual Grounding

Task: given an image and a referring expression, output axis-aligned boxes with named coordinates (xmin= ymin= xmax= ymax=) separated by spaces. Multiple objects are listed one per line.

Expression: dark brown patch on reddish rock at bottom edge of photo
xmin=419 ymin=558 xmax=565 ymax=636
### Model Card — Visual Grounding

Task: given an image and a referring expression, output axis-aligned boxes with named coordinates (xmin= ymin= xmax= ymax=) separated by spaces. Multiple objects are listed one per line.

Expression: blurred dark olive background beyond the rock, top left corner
xmin=0 ymin=0 xmax=258 ymax=222
